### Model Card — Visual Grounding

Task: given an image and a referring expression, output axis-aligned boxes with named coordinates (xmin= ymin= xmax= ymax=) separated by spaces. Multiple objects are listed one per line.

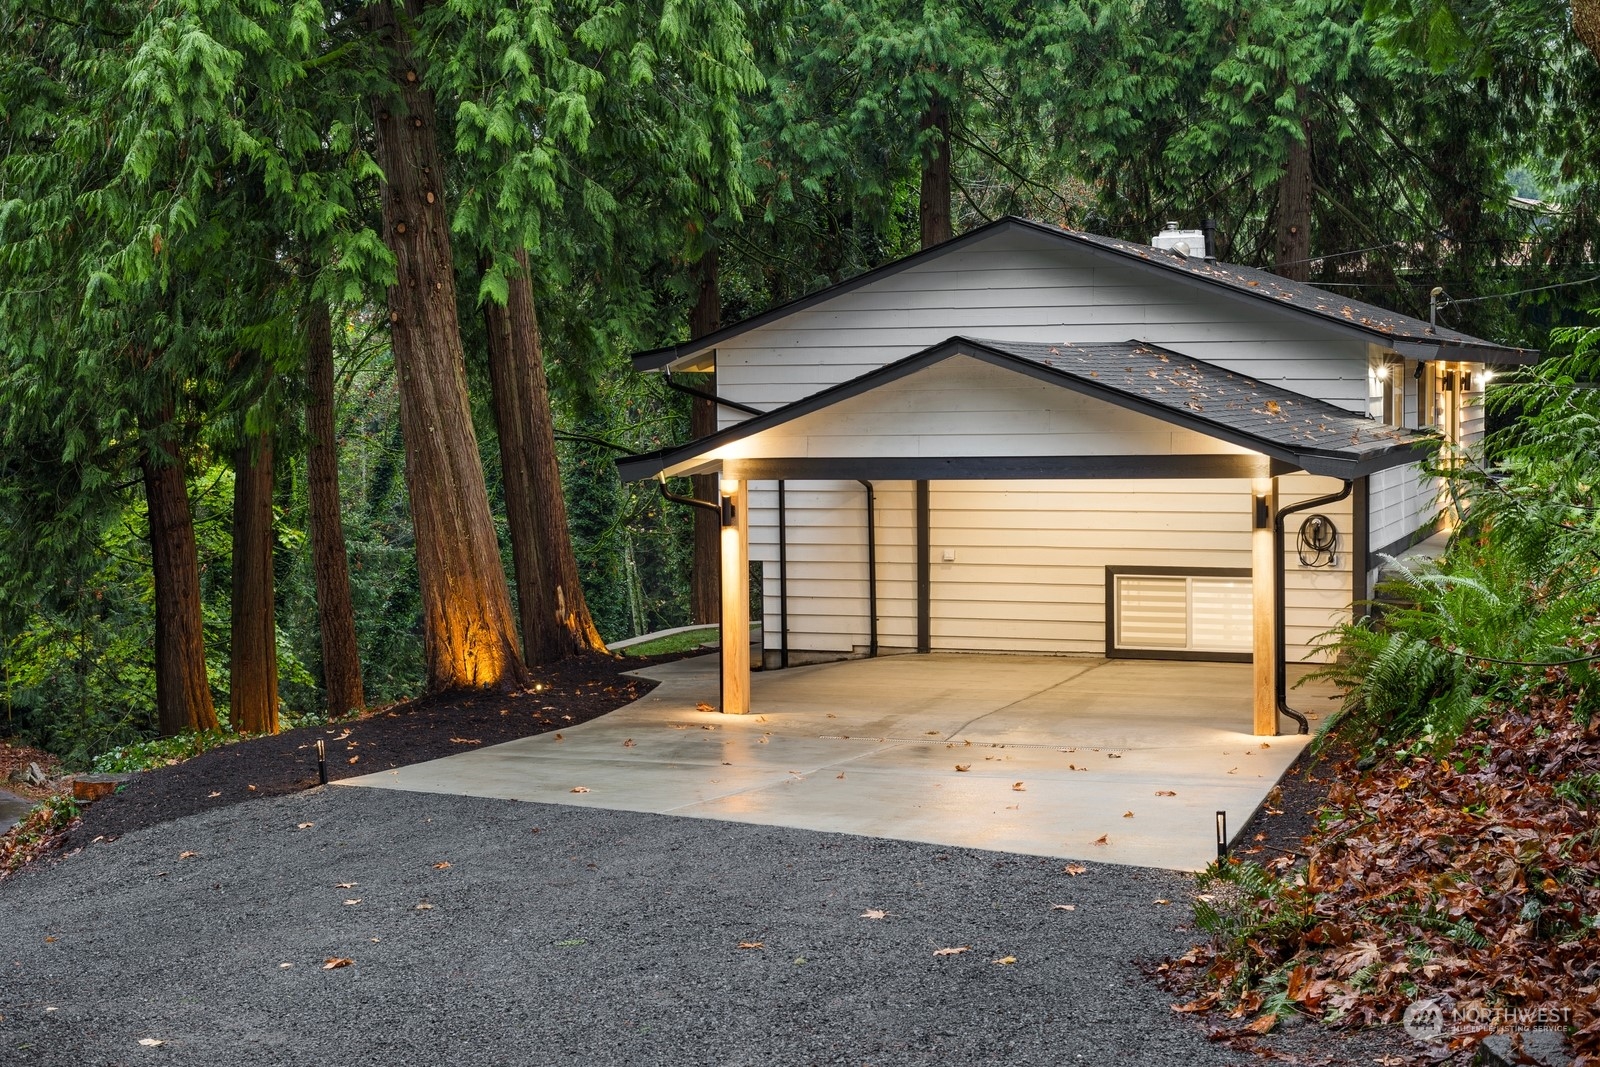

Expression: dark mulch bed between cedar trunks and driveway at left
xmin=58 ymin=656 xmax=682 ymax=853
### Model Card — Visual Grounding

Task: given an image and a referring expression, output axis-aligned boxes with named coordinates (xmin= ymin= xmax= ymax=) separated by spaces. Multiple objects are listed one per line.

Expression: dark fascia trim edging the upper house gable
xmin=632 ymin=216 xmax=1539 ymax=371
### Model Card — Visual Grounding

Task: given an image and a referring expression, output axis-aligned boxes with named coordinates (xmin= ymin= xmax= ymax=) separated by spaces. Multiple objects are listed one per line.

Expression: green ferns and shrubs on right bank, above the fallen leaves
xmin=1315 ymin=310 xmax=1600 ymax=747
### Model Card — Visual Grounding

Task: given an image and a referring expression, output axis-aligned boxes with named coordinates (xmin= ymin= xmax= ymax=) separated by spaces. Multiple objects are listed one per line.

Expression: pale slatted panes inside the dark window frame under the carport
xmin=1114 ymin=574 xmax=1251 ymax=653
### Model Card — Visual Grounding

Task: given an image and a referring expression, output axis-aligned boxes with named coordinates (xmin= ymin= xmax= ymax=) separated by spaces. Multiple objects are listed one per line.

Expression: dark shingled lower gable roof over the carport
xmin=618 ymin=336 xmax=1434 ymax=482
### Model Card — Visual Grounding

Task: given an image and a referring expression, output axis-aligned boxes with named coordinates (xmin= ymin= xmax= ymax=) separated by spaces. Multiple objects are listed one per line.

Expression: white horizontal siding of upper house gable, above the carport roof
xmin=717 ymin=234 xmax=1370 ymax=426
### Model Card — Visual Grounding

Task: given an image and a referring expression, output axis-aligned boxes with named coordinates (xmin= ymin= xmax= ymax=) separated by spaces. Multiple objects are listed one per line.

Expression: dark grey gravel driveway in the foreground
xmin=0 ymin=789 xmax=1245 ymax=1067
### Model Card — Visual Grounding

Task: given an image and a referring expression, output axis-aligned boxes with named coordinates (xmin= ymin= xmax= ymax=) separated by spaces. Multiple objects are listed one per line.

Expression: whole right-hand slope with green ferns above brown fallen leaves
xmin=1165 ymin=337 xmax=1600 ymax=1062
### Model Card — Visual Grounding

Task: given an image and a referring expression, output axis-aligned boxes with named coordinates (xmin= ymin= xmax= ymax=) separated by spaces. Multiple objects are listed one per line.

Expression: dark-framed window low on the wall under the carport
xmin=1106 ymin=566 xmax=1253 ymax=661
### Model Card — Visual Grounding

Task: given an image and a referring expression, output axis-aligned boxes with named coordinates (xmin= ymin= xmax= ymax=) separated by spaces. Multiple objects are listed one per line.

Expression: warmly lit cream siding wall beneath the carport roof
xmin=750 ymin=475 xmax=1350 ymax=659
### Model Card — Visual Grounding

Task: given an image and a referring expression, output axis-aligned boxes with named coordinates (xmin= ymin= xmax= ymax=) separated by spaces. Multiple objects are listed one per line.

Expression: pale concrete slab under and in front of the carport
xmin=339 ymin=654 xmax=1326 ymax=870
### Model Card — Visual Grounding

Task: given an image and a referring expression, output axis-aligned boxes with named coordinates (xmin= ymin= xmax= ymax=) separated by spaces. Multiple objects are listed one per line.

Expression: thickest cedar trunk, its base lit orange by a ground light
xmin=368 ymin=0 xmax=528 ymax=691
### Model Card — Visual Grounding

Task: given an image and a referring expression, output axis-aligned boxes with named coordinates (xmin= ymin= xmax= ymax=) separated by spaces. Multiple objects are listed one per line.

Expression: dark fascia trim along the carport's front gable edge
xmin=618 ymin=336 xmax=1427 ymax=482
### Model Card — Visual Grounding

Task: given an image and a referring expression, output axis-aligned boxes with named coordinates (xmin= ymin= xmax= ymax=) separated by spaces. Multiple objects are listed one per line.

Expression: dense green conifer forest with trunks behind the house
xmin=0 ymin=0 xmax=1600 ymax=765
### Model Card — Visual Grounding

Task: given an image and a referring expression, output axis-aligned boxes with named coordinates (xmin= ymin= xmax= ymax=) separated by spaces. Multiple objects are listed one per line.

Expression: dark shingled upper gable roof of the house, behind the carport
xmin=632 ymin=216 xmax=1539 ymax=371
